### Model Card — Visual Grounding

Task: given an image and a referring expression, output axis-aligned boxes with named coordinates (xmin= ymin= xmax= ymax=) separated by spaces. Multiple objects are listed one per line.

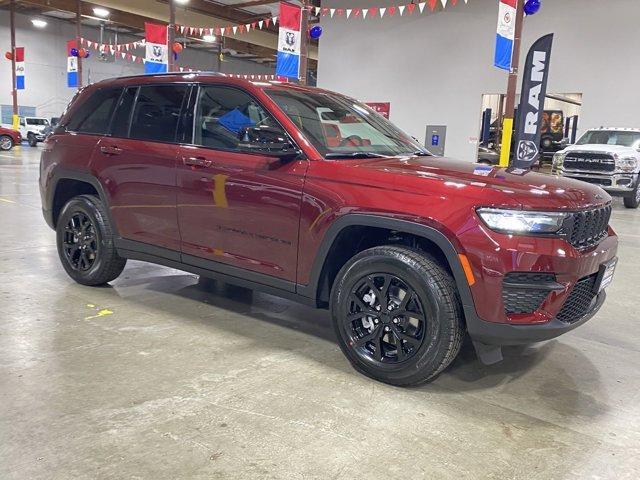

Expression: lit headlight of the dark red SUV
xmin=477 ymin=208 xmax=569 ymax=235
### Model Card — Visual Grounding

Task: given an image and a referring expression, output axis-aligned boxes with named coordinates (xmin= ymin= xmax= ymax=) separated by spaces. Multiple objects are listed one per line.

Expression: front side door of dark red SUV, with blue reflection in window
xmin=177 ymin=85 xmax=307 ymax=288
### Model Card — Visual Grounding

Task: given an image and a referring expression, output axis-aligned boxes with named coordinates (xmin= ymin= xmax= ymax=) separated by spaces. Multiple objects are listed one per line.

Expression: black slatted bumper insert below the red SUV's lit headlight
xmin=502 ymin=272 xmax=555 ymax=315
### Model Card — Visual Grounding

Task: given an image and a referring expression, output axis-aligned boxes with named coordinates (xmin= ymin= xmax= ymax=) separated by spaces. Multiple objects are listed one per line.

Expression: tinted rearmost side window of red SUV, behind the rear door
xmin=67 ymin=88 xmax=122 ymax=135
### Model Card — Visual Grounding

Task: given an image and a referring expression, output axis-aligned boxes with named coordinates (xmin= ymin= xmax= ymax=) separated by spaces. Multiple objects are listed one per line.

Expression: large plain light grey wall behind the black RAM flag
xmin=318 ymin=0 xmax=640 ymax=160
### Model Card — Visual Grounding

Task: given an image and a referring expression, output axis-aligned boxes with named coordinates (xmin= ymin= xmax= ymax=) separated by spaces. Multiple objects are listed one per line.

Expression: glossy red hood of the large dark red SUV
xmin=340 ymin=156 xmax=611 ymax=210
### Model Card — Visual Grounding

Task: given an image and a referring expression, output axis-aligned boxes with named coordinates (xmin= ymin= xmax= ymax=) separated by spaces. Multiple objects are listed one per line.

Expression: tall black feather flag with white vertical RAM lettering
xmin=514 ymin=33 xmax=553 ymax=168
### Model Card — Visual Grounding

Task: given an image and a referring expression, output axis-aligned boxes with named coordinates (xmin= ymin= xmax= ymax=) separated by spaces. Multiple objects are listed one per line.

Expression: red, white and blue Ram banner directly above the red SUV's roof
xmin=276 ymin=2 xmax=302 ymax=80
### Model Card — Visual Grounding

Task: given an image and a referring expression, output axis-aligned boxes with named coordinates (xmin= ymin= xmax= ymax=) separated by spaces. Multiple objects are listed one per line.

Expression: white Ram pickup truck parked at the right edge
xmin=553 ymin=127 xmax=640 ymax=208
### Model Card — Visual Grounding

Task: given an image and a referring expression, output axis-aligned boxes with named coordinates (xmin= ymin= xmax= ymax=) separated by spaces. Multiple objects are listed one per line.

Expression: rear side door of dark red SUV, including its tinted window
xmin=92 ymin=84 xmax=190 ymax=253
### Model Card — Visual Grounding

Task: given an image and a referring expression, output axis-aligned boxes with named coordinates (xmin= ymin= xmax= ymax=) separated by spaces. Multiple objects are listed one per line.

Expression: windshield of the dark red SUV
xmin=265 ymin=89 xmax=430 ymax=158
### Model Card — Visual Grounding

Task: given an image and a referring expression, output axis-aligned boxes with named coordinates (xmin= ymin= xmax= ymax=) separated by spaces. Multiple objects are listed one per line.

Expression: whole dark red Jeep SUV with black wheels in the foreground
xmin=40 ymin=73 xmax=618 ymax=385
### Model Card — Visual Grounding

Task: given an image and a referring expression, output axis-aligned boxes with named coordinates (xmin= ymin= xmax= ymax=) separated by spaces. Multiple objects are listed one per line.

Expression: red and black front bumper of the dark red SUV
xmin=462 ymin=228 xmax=618 ymax=345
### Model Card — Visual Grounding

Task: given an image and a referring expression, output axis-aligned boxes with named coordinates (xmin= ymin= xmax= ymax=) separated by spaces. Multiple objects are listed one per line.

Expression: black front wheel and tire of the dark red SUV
xmin=331 ymin=246 xmax=464 ymax=386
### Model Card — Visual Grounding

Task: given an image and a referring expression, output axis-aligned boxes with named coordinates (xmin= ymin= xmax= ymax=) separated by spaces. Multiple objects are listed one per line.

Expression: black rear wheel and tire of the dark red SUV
xmin=56 ymin=195 xmax=127 ymax=286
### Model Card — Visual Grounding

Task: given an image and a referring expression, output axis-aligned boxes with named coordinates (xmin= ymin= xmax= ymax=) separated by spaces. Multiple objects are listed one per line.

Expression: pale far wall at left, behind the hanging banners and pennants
xmin=0 ymin=11 xmax=274 ymax=121
